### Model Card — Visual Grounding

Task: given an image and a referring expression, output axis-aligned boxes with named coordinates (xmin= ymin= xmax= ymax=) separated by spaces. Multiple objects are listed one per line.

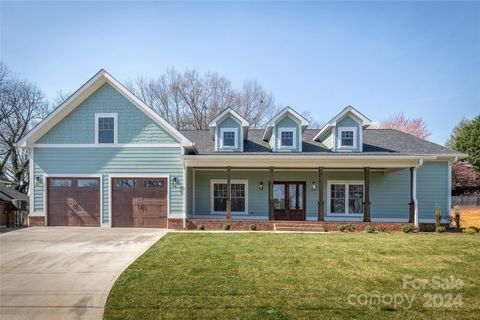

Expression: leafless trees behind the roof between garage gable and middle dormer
xmin=127 ymin=69 xmax=277 ymax=130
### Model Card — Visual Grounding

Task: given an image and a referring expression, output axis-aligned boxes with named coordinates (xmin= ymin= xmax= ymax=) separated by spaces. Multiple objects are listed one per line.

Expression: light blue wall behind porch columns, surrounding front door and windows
xmin=188 ymin=162 xmax=448 ymax=222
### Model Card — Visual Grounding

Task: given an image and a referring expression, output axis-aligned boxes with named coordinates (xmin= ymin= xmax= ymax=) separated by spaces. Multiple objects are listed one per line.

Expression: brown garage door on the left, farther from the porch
xmin=47 ymin=177 xmax=100 ymax=227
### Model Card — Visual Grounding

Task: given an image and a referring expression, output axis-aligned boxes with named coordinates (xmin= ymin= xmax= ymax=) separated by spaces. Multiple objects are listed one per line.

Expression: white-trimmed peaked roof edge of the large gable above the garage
xmin=17 ymin=69 xmax=192 ymax=148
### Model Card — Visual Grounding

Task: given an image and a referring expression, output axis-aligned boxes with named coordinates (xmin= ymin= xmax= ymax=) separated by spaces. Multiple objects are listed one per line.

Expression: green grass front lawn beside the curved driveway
xmin=105 ymin=233 xmax=480 ymax=319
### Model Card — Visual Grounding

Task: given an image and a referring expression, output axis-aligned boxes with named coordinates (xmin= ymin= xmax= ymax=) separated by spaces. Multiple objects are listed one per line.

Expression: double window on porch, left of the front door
xmin=211 ymin=180 xmax=248 ymax=213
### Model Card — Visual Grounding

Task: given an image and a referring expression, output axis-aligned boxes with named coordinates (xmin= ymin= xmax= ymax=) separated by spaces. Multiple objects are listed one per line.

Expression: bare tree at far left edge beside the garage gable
xmin=0 ymin=63 xmax=48 ymax=192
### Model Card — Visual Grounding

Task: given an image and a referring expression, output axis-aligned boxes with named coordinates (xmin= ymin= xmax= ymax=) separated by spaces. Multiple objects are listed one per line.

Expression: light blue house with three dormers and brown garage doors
xmin=19 ymin=70 xmax=464 ymax=229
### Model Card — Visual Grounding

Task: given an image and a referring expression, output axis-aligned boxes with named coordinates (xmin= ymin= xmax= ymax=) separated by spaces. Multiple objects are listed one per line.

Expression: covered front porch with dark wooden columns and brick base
xmin=183 ymin=160 xmax=433 ymax=230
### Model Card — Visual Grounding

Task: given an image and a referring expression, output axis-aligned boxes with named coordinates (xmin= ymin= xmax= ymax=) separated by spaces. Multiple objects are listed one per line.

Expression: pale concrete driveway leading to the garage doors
xmin=0 ymin=227 xmax=167 ymax=319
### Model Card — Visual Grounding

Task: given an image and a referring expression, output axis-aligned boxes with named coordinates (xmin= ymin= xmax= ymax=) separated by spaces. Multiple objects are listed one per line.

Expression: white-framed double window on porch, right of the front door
xmin=329 ymin=182 xmax=364 ymax=214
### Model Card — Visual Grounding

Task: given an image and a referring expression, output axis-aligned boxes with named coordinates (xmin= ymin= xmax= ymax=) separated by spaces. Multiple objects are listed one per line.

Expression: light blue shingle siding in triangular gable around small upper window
xmin=37 ymin=84 xmax=178 ymax=144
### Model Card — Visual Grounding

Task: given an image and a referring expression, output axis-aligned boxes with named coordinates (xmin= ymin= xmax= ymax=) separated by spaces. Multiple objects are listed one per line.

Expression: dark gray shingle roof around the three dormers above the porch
xmin=181 ymin=129 xmax=460 ymax=156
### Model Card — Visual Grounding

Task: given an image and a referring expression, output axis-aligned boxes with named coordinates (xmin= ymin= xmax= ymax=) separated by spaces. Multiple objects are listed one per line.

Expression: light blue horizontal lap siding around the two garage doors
xmin=34 ymin=147 xmax=184 ymax=223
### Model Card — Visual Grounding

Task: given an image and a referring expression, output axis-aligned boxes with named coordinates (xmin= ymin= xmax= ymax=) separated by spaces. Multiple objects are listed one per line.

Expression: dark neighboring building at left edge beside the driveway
xmin=0 ymin=185 xmax=28 ymax=227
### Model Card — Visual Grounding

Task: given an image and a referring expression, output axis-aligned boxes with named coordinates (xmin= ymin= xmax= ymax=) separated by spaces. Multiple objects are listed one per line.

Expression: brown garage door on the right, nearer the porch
xmin=112 ymin=178 xmax=167 ymax=228
